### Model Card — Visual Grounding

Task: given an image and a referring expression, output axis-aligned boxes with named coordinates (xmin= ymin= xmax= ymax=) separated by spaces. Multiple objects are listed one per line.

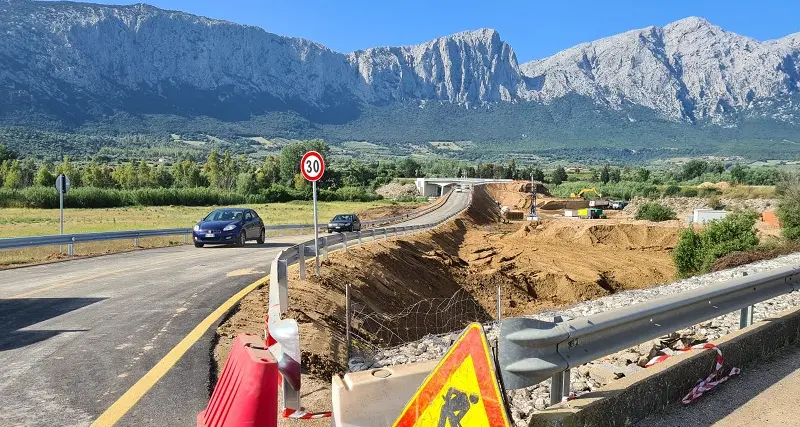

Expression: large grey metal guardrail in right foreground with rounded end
xmin=498 ymin=266 xmax=800 ymax=392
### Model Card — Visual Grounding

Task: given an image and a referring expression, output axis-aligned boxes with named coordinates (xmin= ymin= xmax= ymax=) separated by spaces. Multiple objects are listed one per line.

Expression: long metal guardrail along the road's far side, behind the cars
xmin=0 ymin=197 xmax=446 ymax=255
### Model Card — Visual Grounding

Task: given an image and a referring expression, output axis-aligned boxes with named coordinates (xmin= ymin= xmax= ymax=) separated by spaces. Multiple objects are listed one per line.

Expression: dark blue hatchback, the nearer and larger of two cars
xmin=192 ymin=208 xmax=265 ymax=248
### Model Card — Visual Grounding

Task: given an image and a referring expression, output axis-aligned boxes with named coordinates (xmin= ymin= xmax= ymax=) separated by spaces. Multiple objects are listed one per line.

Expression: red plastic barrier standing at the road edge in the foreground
xmin=197 ymin=334 xmax=278 ymax=427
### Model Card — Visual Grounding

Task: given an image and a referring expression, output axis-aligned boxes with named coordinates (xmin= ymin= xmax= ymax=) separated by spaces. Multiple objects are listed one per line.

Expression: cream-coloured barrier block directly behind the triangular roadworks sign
xmin=331 ymin=360 xmax=439 ymax=427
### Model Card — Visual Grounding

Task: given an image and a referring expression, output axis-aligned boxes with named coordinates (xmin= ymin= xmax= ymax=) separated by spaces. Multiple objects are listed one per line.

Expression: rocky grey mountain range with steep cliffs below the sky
xmin=0 ymin=0 xmax=800 ymax=159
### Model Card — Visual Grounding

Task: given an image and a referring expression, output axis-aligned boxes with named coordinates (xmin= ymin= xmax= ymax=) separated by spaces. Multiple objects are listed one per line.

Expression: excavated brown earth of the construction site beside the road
xmin=214 ymin=182 xmax=724 ymax=425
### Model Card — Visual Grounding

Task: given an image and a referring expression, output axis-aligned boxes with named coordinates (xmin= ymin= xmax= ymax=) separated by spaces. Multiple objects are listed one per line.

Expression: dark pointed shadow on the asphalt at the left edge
xmin=0 ymin=298 xmax=105 ymax=351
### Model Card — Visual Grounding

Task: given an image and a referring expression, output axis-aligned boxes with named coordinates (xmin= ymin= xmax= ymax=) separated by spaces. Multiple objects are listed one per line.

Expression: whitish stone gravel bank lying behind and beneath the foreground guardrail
xmin=362 ymin=253 xmax=800 ymax=426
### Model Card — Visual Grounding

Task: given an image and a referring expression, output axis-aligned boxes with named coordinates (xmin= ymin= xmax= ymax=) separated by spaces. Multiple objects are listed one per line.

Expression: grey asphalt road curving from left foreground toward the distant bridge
xmin=0 ymin=193 xmax=467 ymax=426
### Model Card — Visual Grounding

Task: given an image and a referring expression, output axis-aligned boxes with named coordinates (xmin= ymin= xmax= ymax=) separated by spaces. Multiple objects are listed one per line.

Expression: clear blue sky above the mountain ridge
xmin=67 ymin=0 xmax=800 ymax=62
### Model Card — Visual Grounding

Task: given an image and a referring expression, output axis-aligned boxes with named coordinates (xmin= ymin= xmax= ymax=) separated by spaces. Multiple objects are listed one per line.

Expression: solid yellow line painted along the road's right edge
xmin=92 ymin=276 xmax=269 ymax=427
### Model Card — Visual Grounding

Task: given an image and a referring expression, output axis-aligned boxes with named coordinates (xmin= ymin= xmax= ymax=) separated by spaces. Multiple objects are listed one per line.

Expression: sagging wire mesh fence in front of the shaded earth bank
xmin=348 ymin=289 xmax=492 ymax=370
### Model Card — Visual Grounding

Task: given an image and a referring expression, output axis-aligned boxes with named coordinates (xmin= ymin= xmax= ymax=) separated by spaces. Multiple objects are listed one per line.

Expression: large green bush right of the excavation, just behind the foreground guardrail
xmin=673 ymin=212 xmax=758 ymax=277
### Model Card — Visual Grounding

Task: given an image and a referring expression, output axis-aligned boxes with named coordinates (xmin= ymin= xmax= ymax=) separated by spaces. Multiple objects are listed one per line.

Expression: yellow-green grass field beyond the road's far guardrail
xmin=0 ymin=200 xmax=419 ymax=268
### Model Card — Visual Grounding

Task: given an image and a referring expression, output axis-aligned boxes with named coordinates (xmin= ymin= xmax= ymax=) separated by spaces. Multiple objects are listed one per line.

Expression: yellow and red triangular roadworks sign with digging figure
xmin=393 ymin=323 xmax=510 ymax=427
